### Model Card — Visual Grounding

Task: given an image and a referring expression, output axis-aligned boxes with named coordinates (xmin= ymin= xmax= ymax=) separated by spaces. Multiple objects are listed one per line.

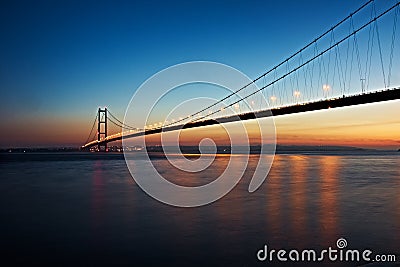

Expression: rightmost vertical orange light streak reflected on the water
xmin=319 ymin=156 xmax=340 ymax=244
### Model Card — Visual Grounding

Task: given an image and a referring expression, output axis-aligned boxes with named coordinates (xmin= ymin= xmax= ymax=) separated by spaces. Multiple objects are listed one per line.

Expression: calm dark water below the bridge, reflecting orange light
xmin=0 ymin=153 xmax=400 ymax=266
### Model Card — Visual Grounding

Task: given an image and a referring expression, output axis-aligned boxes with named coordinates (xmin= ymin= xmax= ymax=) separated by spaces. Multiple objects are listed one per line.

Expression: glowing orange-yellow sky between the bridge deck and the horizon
xmin=146 ymin=101 xmax=400 ymax=150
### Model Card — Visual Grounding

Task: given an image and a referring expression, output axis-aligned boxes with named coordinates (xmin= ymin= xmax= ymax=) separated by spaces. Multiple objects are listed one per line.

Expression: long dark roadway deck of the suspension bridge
xmin=85 ymin=88 xmax=400 ymax=148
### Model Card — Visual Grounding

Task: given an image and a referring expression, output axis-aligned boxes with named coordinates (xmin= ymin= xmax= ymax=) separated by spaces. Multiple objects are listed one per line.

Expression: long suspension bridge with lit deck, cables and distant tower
xmin=81 ymin=0 xmax=400 ymax=151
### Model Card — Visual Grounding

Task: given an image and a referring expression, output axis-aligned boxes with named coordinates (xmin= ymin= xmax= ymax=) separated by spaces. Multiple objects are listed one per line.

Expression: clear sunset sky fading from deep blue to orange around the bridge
xmin=0 ymin=0 xmax=400 ymax=149
